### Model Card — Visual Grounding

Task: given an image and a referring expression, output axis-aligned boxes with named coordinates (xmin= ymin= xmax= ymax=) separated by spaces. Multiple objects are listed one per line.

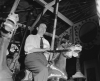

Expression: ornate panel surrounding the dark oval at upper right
xmin=73 ymin=16 xmax=100 ymax=49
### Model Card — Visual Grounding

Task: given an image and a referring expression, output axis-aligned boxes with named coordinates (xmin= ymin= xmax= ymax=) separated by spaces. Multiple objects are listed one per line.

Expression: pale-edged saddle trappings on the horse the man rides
xmin=48 ymin=64 xmax=68 ymax=79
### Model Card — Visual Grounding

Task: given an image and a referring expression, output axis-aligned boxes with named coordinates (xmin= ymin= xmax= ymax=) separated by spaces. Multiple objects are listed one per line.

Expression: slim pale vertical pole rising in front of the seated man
xmin=50 ymin=0 xmax=59 ymax=61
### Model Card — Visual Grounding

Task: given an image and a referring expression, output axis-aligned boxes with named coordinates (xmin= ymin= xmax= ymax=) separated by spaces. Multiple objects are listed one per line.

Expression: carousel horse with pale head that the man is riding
xmin=21 ymin=42 xmax=82 ymax=81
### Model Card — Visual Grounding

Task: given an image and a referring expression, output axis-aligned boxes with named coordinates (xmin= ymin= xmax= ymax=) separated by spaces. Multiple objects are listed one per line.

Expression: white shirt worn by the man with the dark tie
xmin=24 ymin=34 xmax=50 ymax=54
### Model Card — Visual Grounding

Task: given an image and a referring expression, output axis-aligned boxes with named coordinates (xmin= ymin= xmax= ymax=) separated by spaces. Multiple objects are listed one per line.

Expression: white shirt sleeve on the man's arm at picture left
xmin=24 ymin=35 xmax=34 ymax=53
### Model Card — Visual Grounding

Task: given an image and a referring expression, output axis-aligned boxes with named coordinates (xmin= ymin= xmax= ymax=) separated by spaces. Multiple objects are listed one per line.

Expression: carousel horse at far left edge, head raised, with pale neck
xmin=0 ymin=1 xmax=19 ymax=81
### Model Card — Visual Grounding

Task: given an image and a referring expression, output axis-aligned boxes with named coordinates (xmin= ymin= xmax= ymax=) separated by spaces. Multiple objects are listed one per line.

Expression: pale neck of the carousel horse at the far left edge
xmin=0 ymin=37 xmax=12 ymax=81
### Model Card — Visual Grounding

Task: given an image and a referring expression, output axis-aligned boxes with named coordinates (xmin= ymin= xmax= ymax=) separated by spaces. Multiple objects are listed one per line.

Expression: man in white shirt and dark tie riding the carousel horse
xmin=24 ymin=23 xmax=50 ymax=81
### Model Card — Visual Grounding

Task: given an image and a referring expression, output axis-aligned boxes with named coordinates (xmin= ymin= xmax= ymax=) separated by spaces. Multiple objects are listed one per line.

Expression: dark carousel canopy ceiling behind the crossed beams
xmin=0 ymin=0 xmax=96 ymax=42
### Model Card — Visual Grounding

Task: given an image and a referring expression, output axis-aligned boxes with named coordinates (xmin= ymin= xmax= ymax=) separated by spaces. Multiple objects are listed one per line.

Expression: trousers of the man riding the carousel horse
xmin=25 ymin=53 xmax=48 ymax=81
